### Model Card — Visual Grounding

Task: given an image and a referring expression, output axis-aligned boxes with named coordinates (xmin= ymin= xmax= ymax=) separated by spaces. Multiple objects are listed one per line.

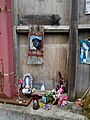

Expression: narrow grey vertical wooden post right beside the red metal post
xmin=12 ymin=0 xmax=20 ymax=81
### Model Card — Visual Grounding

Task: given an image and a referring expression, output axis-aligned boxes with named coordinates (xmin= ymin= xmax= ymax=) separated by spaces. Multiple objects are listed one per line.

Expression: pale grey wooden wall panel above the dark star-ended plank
xmin=18 ymin=0 xmax=70 ymax=24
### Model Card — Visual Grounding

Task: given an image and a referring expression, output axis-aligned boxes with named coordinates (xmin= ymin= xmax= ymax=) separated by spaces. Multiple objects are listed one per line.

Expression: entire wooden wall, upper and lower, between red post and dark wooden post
xmin=12 ymin=0 xmax=70 ymax=89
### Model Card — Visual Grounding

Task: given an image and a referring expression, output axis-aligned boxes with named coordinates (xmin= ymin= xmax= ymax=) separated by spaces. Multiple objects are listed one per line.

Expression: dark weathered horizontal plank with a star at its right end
xmin=19 ymin=14 xmax=61 ymax=25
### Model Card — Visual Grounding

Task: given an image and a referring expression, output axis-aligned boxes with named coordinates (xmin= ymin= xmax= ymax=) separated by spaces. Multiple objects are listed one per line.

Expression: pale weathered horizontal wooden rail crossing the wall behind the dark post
xmin=16 ymin=24 xmax=90 ymax=33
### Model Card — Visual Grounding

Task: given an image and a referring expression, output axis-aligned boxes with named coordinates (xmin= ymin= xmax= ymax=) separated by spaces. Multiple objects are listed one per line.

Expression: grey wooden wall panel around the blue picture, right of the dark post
xmin=76 ymin=30 xmax=90 ymax=97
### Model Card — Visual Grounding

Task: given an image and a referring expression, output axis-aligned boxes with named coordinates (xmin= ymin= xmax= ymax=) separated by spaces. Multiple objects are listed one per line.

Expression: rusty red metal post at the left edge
xmin=0 ymin=0 xmax=15 ymax=98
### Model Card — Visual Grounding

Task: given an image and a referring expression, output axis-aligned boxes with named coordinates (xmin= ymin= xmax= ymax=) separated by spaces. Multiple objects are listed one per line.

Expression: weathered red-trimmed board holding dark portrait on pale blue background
xmin=28 ymin=33 xmax=44 ymax=65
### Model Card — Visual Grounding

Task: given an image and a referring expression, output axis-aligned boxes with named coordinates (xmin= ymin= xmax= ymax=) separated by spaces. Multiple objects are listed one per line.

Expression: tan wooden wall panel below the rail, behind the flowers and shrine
xmin=19 ymin=34 xmax=68 ymax=89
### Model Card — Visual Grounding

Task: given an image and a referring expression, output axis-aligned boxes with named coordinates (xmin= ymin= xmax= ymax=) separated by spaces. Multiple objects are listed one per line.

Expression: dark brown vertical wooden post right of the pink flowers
xmin=68 ymin=0 xmax=78 ymax=100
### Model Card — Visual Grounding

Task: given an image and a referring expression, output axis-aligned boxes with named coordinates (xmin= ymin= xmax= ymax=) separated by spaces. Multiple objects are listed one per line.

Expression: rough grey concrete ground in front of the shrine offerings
xmin=0 ymin=102 xmax=88 ymax=120
